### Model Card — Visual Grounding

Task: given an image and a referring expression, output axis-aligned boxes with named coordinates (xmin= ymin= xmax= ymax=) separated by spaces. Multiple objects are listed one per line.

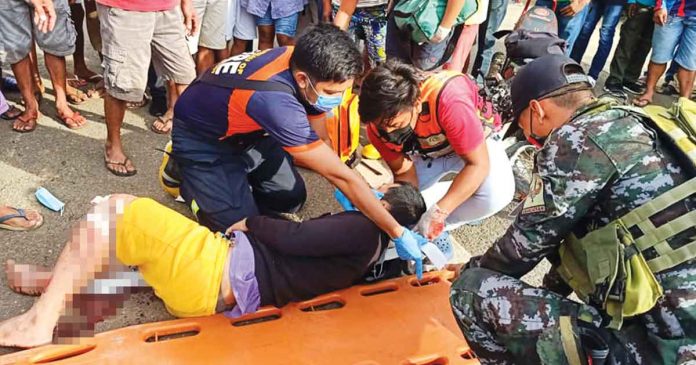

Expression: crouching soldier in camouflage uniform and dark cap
xmin=450 ymin=55 xmax=696 ymax=364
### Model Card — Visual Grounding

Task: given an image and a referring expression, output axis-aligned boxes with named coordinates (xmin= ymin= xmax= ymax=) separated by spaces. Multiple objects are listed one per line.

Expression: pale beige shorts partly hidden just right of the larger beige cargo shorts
xmin=188 ymin=0 xmax=227 ymax=53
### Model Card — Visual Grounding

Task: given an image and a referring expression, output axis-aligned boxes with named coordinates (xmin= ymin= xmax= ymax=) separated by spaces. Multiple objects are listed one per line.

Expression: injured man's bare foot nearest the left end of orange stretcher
xmin=0 ymin=308 xmax=54 ymax=348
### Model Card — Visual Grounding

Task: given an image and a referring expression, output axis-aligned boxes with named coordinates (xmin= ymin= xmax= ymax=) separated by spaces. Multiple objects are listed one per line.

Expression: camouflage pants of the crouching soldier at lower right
xmin=450 ymin=268 xmax=696 ymax=365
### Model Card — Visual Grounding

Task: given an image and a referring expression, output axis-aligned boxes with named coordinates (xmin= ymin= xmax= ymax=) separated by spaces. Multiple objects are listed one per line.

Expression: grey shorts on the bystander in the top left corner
xmin=0 ymin=0 xmax=76 ymax=64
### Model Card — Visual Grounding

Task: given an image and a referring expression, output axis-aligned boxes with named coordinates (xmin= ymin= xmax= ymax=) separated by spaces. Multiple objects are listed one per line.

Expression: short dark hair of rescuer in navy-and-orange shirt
xmin=290 ymin=24 xmax=363 ymax=82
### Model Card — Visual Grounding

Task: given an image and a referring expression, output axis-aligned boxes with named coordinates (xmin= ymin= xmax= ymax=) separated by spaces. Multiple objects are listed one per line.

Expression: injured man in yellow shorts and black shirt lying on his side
xmin=0 ymin=184 xmax=425 ymax=347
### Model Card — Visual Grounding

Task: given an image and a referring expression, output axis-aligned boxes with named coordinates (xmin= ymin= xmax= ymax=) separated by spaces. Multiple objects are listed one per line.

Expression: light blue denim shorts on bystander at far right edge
xmin=650 ymin=16 xmax=696 ymax=71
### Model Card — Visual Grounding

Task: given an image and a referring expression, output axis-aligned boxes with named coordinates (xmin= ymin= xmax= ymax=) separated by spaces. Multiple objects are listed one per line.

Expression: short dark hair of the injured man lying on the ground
xmin=382 ymin=181 xmax=427 ymax=227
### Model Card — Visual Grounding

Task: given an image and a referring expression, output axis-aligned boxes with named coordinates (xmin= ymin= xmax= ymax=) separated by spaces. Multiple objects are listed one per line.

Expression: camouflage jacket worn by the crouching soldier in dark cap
xmin=473 ymin=100 xmax=696 ymax=350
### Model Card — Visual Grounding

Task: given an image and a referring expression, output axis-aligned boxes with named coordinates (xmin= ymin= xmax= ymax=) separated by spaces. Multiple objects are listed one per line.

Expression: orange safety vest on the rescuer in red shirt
xmin=369 ymin=71 xmax=500 ymax=158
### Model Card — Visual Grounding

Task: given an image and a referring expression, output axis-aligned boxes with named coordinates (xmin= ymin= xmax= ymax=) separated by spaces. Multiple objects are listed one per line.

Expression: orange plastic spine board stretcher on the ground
xmin=0 ymin=271 xmax=478 ymax=365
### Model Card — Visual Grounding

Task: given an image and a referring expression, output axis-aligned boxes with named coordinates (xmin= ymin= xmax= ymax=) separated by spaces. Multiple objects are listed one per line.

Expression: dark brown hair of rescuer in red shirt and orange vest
xmin=358 ymin=59 xmax=424 ymax=124
